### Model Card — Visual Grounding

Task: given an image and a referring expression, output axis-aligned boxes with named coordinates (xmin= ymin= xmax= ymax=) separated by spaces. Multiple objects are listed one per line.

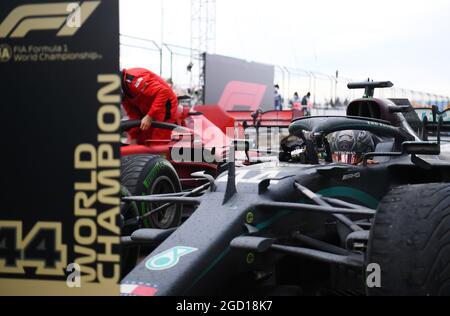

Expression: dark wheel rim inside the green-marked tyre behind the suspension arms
xmin=150 ymin=176 xmax=177 ymax=229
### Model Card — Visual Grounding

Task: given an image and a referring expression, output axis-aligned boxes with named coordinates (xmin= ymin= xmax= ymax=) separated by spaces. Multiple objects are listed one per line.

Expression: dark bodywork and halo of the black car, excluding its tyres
xmin=122 ymin=82 xmax=450 ymax=296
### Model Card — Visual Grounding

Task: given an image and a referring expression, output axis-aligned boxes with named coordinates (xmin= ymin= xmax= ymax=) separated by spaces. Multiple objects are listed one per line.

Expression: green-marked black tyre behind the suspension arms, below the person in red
xmin=120 ymin=155 xmax=183 ymax=229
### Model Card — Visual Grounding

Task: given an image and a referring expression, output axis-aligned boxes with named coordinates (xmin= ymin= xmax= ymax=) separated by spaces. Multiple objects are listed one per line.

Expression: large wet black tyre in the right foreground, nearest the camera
xmin=366 ymin=183 xmax=450 ymax=296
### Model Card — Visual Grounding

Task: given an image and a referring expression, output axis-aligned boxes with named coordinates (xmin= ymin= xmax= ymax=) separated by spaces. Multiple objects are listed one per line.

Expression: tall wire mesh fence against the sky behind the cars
xmin=120 ymin=34 xmax=450 ymax=111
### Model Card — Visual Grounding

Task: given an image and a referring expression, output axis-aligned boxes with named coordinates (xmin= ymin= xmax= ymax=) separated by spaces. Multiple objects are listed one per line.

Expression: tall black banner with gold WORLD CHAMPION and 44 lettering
xmin=0 ymin=0 xmax=120 ymax=295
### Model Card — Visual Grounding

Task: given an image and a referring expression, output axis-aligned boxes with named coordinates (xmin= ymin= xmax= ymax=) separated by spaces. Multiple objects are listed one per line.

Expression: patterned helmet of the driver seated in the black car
xmin=330 ymin=130 xmax=375 ymax=165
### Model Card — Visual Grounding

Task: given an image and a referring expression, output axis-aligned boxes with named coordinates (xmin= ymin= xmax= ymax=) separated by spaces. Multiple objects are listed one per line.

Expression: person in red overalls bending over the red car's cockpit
xmin=122 ymin=68 xmax=178 ymax=144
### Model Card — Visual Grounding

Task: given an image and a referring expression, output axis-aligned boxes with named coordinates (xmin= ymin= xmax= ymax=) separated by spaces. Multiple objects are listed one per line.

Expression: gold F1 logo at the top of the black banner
xmin=0 ymin=1 xmax=101 ymax=38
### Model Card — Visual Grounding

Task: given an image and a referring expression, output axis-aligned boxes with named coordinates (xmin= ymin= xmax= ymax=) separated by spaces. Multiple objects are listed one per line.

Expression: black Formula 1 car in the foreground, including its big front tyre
xmin=121 ymin=82 xmax=450 ymax=296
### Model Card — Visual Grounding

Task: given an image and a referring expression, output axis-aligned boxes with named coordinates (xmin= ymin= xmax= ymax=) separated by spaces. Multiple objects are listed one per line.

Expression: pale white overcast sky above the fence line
xmin=120 ymin=0 xmax=450 ymax=95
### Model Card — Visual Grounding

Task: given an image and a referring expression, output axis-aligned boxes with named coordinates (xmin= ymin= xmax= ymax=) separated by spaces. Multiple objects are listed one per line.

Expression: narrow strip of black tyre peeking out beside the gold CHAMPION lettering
xmin=120 ymin=186 xmax=140 ymax=278
